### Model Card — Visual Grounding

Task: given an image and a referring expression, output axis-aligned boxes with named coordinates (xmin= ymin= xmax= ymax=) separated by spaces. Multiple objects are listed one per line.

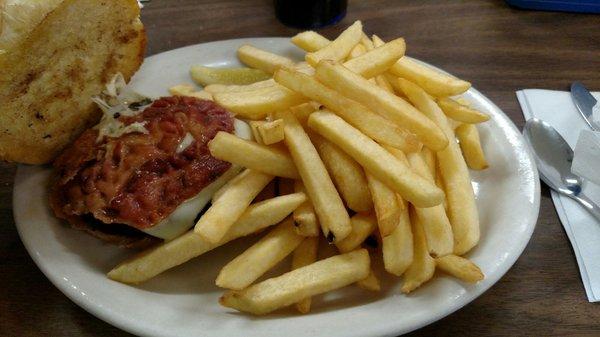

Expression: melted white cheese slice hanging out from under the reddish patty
xmin=143 ymin=119 xmax=252 ymax=240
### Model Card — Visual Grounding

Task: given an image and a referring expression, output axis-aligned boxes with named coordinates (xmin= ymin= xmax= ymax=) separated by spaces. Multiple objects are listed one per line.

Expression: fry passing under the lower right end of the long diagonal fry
xmin=407 ymin=153 xmax=454 ymax=257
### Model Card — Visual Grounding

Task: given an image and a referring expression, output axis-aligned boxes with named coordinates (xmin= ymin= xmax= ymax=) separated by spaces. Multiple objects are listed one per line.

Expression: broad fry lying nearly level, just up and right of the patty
xmin=213 ymin=85 xmax=306 ymax=120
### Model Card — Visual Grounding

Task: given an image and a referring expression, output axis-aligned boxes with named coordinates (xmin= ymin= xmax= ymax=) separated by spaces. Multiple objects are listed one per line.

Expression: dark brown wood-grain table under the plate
xmin=0 ymin=0 xmax=600 ymax=336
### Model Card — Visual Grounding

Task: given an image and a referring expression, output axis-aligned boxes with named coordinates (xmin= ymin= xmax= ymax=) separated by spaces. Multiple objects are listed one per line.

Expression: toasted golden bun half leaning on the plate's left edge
xmin=0 ymin=0 xmax=146 ymax=164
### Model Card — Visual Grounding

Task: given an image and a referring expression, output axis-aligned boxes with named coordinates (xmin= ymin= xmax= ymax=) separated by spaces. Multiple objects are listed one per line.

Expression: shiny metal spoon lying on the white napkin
xmin=523 ymin=118 xmax=600 ymax=221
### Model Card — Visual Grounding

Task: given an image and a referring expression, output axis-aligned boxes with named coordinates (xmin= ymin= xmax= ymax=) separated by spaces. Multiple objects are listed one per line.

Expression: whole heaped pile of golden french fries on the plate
xmin=108 ymin=21 xmax=489 ymax=315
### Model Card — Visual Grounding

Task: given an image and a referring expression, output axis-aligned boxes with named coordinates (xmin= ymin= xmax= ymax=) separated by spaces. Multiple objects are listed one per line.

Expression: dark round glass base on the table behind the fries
xmin=275 ymin=0 xmax=348 ymax=29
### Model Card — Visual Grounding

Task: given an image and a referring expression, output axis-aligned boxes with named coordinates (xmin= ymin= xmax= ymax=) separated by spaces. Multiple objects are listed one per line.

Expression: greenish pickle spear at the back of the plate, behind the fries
xmin=190 ymin=66 xmax=270 ymax=86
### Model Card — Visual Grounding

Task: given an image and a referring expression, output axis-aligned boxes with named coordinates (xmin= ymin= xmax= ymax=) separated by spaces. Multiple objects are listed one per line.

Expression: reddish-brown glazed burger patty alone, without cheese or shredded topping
xmin=50 ymin=96 xmax=233 ymax=246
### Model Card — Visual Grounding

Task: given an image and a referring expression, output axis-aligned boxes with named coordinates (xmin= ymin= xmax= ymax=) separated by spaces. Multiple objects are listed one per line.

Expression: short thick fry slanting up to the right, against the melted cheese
xmin=194 ymin=169 xmax=273 ymax=243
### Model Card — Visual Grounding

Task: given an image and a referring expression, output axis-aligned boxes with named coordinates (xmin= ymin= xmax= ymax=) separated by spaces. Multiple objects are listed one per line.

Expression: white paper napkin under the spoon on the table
xmin=517 ymin=89 xmax=600 ymax=302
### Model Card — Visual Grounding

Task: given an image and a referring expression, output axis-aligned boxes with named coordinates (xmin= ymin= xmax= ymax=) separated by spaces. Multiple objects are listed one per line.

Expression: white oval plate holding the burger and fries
xmin=13 ymin=38 xmax=540 ymax=337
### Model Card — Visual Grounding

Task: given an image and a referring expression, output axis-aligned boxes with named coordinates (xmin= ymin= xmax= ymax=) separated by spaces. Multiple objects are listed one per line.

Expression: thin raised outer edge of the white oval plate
xmin=12 ymin=36 xmax=541 ymax=336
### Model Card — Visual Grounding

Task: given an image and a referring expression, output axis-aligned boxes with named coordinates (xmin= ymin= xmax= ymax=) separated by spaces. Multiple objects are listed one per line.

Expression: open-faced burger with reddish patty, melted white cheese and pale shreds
xmin=50 ymin=75 xmax=251 ymax=247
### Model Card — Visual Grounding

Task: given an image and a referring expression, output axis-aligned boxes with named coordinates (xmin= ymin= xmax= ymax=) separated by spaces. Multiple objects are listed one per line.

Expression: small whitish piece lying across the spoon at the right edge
xmin=571 ymin=130 xmax=600 ymax=185
